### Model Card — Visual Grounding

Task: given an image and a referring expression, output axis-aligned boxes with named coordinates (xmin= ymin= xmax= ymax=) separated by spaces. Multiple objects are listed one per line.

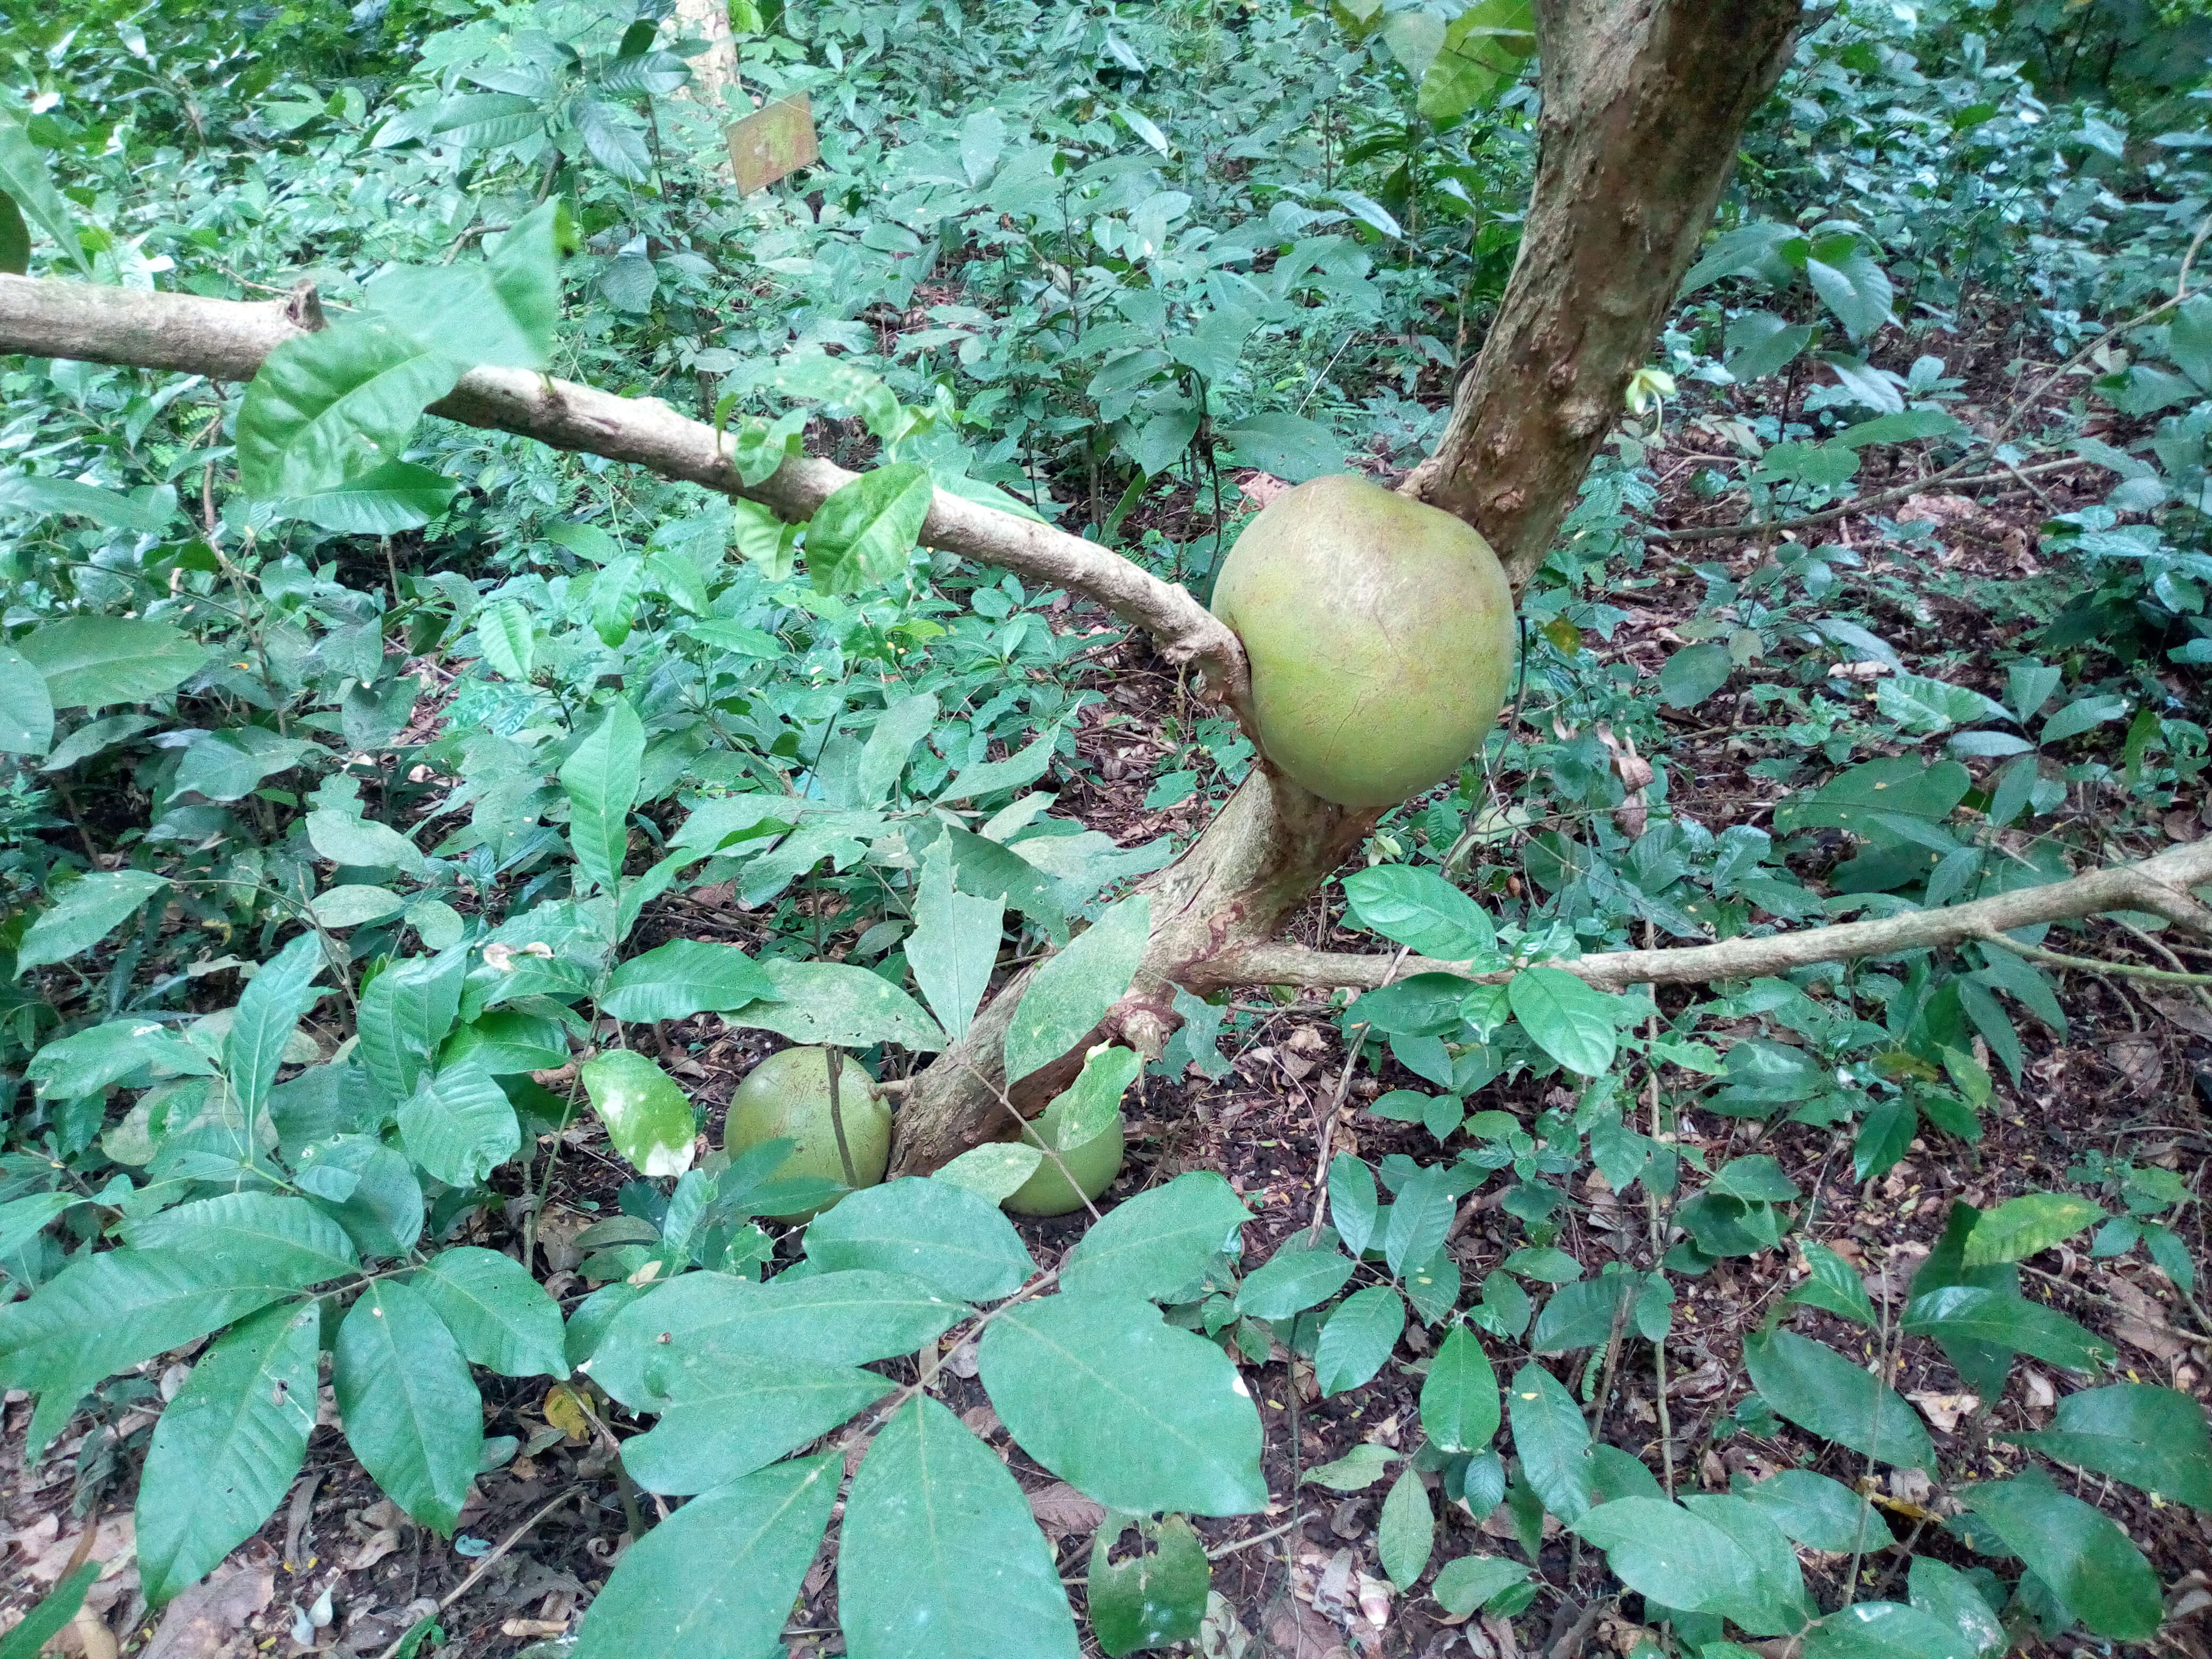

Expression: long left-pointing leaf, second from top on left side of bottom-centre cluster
xmin=582 ymin=1270 xmax=969 ymax=1411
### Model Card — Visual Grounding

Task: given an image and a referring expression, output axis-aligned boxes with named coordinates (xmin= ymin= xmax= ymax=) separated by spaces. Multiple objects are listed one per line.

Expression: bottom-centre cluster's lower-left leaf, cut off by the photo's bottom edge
xmin=575 ymin=1451 xmax=840 ymax=1659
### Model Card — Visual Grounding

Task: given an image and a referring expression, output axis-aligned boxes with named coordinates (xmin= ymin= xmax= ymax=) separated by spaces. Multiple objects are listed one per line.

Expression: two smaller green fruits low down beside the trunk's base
xmin=721 ymin=1049 xmax=1124 ymax=1223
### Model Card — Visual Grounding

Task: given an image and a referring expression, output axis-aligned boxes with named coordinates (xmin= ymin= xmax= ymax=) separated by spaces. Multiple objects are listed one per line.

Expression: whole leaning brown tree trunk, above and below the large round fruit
xmin=896 ymin=0 xmax=1800 ymax=1175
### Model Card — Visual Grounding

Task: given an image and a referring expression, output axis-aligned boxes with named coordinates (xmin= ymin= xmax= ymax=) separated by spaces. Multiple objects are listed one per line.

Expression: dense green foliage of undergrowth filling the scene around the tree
xmin=0 ymin=0 xmax=2212 ymax=1659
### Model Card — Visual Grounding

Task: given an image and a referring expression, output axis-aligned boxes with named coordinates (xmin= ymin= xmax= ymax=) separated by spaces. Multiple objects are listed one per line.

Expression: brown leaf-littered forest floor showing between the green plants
xmin=0 ymin=376 xmax=2212 ymax=1659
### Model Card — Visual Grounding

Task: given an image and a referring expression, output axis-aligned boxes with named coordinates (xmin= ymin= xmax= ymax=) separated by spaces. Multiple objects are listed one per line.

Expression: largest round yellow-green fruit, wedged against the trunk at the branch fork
xmin=1214 ymin=475 xmax=1515 ymax=807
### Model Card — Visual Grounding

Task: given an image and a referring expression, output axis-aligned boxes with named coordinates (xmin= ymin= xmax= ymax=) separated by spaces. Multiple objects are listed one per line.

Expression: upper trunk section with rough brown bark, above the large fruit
xmin=1402 ymin=0 xmax=1800 ymax=593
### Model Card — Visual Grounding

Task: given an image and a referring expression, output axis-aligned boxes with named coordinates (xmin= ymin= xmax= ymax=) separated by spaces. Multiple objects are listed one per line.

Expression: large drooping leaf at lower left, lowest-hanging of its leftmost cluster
xmin=137 ymin=1301 xmax=323 ymax=1606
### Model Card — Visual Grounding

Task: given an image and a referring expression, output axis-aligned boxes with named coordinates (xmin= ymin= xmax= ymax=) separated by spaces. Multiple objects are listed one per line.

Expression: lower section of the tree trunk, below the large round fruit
xmin=891 ymin=763 xmax=1376 ymax=1175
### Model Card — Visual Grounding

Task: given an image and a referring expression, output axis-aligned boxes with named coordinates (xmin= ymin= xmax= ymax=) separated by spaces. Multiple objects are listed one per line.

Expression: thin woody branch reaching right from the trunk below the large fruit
xmin=1184 ymin=839 xmax=2212 ymax=993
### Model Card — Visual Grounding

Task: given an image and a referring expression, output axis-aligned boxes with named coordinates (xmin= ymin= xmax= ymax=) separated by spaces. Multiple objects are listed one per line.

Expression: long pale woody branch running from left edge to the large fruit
xmin=0 ymin=274 xmax=1247 ymax=708
